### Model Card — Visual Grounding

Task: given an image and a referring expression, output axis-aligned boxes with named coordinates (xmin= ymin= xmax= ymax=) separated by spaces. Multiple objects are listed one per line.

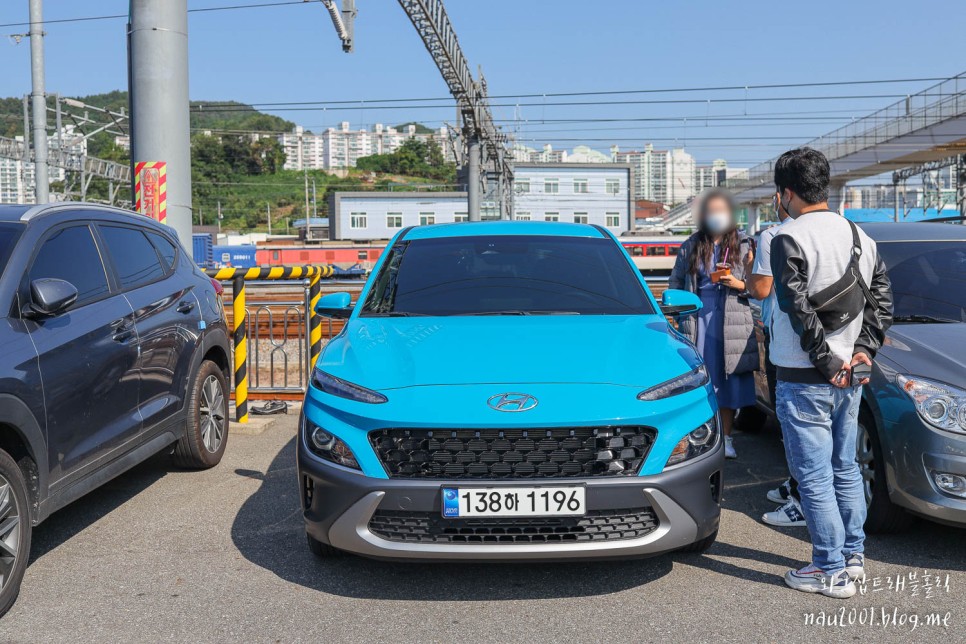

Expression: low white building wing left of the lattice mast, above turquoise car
xmin=329 ymin=192 xmax=468 ymax=241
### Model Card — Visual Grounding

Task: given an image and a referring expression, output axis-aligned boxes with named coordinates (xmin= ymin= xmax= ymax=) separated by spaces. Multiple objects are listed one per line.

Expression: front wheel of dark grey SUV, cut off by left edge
xmin=0 ymin=451 xmax=32 ymax=617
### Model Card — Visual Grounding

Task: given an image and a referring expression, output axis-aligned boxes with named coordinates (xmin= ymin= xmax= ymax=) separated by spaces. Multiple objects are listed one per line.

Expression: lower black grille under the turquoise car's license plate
xmin=369 ymin=508 xmax=659 ymax=544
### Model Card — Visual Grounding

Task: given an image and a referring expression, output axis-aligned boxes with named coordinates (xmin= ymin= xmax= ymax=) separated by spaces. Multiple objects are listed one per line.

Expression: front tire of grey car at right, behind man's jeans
xmin=855 ymin=409 xmax=915 ymax=534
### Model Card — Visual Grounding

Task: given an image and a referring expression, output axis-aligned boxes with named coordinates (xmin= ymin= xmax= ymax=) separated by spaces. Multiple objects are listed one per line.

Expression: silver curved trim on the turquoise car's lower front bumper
xmin=329 ymin=487 xmax=698 ymax=560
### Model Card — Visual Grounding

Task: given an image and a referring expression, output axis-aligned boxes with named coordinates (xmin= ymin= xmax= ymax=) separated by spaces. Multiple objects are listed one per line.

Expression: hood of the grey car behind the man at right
xmin=882 ymin=322 xmax=966 ymax=387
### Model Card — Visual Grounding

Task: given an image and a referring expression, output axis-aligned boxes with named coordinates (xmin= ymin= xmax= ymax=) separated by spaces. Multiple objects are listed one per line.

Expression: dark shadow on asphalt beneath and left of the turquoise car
xmin=232 ymin=438 xmax=676 ymax=601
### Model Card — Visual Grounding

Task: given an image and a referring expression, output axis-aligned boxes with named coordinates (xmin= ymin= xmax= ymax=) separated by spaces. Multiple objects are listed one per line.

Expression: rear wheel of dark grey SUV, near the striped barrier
xmin=173 ymin=360 xmax=229 ymax=469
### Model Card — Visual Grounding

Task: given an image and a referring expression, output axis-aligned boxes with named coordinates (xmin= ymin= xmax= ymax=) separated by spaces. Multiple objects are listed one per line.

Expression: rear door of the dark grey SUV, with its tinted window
xmin=97 ymin=222 xmax=201 ymax=431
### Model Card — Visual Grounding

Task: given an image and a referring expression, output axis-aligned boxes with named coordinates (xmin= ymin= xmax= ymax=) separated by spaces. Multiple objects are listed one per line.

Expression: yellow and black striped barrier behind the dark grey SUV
xmin=205 ymin=266 xmax=335 ymax=423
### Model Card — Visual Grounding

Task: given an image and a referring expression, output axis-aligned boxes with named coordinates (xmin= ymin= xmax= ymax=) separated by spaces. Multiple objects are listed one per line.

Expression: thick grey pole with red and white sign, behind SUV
xmin=128 ymin=0 xmax=192 ymax=248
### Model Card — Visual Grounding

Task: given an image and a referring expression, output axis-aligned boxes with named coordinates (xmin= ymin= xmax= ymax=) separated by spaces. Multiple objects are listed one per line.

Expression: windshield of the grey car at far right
xmin=878 ymin=241 xmax=966 ymax=323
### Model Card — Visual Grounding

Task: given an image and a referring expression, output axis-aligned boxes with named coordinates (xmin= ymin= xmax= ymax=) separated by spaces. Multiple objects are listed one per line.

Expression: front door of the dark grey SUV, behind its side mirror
xmin=21 ymin=223 xmax=141 ymax=486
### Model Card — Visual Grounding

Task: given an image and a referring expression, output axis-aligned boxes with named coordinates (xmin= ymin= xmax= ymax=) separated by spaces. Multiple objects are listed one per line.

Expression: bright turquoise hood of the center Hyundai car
xmin=318 ymin=315 xmax=698 ymax=390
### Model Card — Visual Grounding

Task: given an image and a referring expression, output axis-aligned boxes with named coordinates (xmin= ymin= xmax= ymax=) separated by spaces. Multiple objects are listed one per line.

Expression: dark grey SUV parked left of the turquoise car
xmin=0 ymin=203 xmax=231 ymax=615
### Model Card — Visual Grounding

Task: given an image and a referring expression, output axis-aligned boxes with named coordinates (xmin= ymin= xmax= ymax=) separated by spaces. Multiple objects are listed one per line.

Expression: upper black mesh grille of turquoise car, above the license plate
xmin=369 ymin=427 xmax=655 ymax=479
